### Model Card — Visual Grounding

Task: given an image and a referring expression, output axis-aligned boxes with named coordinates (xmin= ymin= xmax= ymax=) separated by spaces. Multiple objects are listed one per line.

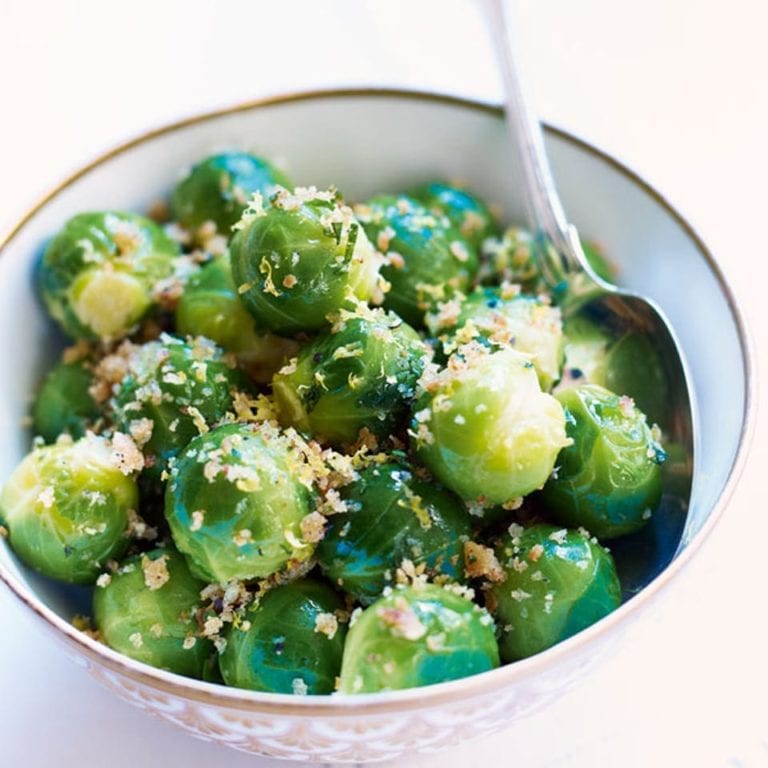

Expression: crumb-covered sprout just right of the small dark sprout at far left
xmin=113 ymin=334 xmax=247 ymax=480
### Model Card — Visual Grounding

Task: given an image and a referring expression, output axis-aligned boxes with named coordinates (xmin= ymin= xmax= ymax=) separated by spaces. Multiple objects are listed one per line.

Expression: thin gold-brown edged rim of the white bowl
xmin=0 ymin=87 xmax=757 ymax=717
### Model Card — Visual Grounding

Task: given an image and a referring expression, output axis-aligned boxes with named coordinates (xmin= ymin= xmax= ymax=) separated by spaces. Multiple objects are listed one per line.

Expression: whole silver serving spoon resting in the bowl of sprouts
xmin=484 ymin=0 xmax=701 ymax=564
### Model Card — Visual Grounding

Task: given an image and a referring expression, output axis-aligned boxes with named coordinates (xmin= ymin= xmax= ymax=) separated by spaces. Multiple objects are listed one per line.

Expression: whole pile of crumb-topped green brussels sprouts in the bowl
xmin=0 ymin=152 xmax=664 ymax=694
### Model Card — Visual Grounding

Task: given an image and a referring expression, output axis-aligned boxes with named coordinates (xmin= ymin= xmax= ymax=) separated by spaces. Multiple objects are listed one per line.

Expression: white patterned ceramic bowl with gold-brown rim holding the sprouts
xmin=0 ymin=90 xmax=753 ymax=763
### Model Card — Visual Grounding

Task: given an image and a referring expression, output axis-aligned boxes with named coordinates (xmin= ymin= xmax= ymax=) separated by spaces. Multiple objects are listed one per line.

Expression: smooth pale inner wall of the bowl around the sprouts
xmin=0 ymin=92 xmax=747 ymax=632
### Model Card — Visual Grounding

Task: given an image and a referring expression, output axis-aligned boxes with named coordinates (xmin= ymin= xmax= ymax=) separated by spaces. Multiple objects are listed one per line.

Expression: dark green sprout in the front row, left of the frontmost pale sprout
xmin=219 ymin=580 xmax=346 ymax=695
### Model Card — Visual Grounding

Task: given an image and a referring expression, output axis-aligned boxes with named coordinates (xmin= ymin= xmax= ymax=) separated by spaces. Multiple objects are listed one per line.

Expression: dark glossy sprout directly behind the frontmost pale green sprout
xmin=317 ymin=462 xmax=471 ymax=603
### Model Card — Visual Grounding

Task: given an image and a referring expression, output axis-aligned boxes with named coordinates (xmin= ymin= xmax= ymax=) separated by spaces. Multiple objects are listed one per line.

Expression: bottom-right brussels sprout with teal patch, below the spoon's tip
xmin=487 ymin=525 xmax=621 ymax=662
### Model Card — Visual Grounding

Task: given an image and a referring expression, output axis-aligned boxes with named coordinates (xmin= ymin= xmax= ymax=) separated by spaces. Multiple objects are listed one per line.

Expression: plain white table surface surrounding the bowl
xmin=0 ymin=0 xmax=768 ymax=768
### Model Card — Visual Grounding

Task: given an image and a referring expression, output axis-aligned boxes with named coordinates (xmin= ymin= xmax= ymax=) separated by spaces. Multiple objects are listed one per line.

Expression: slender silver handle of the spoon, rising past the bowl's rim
xmin=482 ymin=0 xmax=584 ymax=287
